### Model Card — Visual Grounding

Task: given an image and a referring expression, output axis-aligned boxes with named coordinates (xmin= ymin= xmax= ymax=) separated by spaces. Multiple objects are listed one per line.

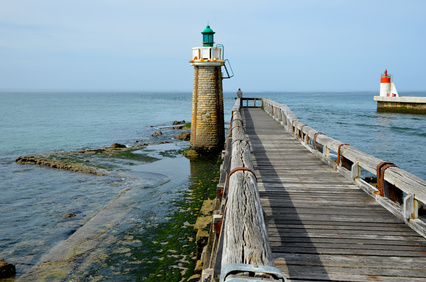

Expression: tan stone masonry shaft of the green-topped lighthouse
xmin=191 ymin=66 xmax=224 ymax=153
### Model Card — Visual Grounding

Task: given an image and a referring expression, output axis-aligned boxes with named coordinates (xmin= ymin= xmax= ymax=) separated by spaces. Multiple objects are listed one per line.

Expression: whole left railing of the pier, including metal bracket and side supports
xmin=202 ymin=98 xmax=286 ymax=281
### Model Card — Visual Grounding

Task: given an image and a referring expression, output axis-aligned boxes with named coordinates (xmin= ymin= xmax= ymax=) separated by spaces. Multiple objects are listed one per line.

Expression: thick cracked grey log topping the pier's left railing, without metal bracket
xmin=221 ymin=109 xmax=274 ymax=268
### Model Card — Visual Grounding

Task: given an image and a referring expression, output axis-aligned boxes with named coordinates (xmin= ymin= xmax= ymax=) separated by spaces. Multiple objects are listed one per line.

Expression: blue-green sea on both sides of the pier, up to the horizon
xmin=0 ymin=90 xmax=426 ymax=281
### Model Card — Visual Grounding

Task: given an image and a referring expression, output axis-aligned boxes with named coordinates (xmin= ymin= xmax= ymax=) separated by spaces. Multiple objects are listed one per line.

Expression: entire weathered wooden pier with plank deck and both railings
xmin=202 ymin=100 xmax=426 ymax=281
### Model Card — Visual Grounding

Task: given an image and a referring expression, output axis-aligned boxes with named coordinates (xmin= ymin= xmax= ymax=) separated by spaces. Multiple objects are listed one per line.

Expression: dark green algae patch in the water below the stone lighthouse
xmin=91 ymin=155 xmax=220 ymax=281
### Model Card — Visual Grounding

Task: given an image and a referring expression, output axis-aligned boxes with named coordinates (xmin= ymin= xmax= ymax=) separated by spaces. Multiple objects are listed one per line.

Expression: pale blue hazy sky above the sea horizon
xmin=0 ymin=0 xmax=426 ymax=92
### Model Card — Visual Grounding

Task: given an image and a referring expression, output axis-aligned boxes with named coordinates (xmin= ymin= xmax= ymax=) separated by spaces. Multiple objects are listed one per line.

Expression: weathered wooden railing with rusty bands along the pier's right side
xmin=263 ymin=99 xmax=426 ymax=237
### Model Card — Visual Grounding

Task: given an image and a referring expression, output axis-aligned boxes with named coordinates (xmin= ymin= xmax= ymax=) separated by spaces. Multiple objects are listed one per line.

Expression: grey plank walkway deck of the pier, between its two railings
xmin=241 ymin=108 xmax=426 ymax=281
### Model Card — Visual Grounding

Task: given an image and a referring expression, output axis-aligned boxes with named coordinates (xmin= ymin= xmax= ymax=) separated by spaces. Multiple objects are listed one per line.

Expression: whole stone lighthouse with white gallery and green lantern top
xmin=189 ymin=25 xmax=225 ymax=155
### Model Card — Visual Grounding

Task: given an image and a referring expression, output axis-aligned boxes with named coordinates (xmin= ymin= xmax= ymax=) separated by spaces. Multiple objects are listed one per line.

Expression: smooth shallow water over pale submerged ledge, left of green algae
xmin=17 ymin=142 xmax=195 ymax=280
